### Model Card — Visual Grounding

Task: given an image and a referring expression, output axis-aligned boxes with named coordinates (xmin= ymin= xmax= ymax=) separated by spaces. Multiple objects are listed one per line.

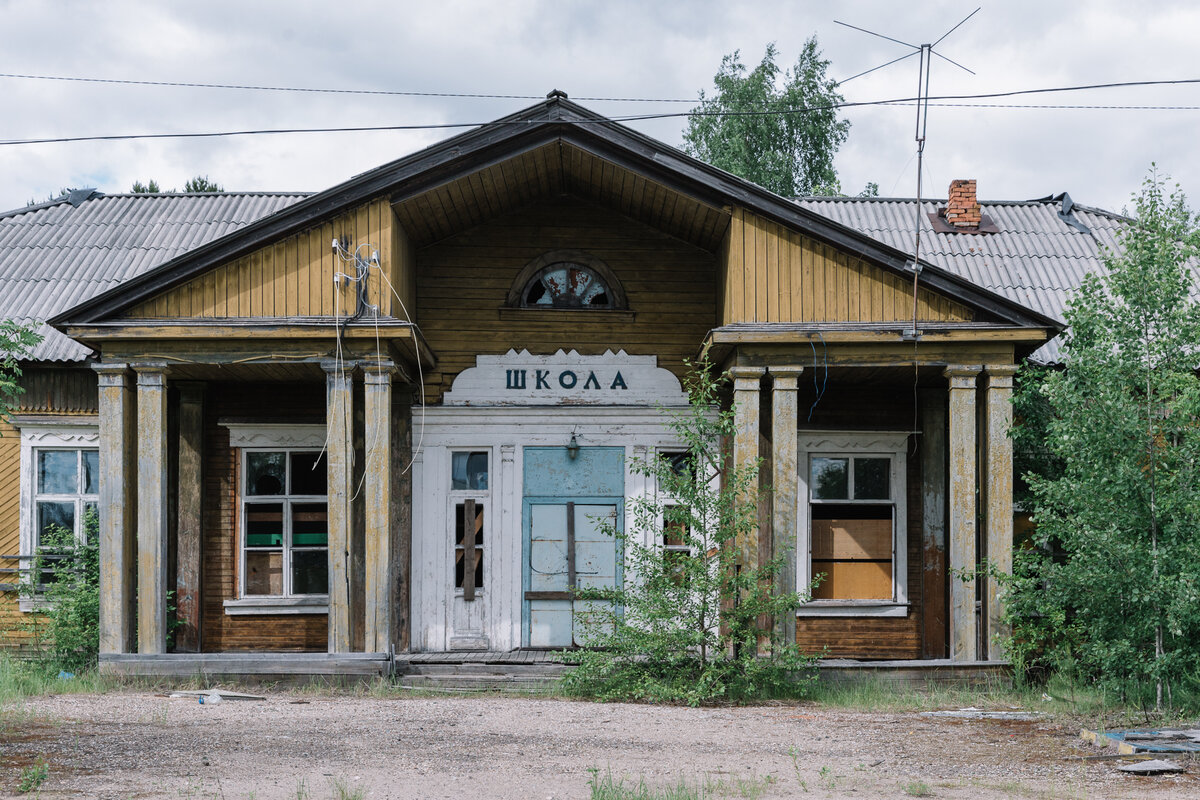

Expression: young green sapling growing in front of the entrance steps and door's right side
xmin=564 ymin=362 xmax=814 ymax=705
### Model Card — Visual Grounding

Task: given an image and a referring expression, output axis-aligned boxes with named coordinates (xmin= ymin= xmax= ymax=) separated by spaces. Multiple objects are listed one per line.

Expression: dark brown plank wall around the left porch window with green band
xmin=200 ymin=383 xmax=328 ymax=652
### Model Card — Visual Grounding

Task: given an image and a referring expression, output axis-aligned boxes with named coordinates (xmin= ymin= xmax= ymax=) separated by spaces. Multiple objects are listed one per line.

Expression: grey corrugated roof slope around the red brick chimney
xmin=797 ymin=196 xmax=1129 ymax=362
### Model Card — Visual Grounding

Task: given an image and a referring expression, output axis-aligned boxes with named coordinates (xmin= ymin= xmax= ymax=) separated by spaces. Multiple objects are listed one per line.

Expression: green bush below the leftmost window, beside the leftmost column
xmin=22 ymin=507 xmax=100 ymax=672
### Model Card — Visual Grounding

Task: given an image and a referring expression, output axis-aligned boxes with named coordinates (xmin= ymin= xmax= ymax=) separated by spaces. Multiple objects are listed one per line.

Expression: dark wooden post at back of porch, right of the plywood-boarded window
xmin=920 ymin=389 xmax=947 ymax=658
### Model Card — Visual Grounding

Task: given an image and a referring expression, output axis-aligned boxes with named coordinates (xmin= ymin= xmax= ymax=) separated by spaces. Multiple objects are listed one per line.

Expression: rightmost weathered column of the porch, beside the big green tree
xmin=984 ymin=365 xmax=1016 ymax=661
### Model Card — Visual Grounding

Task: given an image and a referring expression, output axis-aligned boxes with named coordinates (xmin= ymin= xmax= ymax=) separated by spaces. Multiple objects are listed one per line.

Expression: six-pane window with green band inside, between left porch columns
xmin=240 ymin=450 xmax=329 ymax=600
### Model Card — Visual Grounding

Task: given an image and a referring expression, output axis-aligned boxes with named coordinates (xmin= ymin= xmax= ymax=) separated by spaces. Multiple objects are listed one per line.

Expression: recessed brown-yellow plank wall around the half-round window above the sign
xmin=416 ymin=197 xmax=718 ymax=403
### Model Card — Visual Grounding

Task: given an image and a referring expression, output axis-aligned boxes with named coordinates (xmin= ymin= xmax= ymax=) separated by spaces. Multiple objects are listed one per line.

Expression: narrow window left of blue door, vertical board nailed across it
xmin=450 ymin=450 xmax=491 ymax=602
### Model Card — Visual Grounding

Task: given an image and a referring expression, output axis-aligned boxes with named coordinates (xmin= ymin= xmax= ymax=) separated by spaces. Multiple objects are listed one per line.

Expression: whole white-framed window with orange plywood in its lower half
xmin=797 ymin=432 xmax=908 ymax=615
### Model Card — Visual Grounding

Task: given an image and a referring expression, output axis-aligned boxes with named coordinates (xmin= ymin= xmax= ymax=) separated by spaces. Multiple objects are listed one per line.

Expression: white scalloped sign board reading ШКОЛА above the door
xmin=442 ymin=350 xmax=688 ymax=405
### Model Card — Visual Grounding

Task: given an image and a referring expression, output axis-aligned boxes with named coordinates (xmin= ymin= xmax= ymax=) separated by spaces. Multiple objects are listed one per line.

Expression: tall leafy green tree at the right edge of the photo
xmin=1008 ymin=167 xmax=1200 ymax=708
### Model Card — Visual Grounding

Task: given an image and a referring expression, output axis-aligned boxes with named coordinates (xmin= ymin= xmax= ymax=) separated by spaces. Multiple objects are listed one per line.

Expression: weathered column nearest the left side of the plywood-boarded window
xmin=770 ymin=367 xmax=804 ymax=644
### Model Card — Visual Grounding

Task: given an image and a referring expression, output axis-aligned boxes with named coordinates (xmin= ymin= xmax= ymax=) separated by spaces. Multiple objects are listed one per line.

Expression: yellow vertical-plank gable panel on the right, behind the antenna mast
xmin=721 ymin=209 xmax=972 ymax=324
